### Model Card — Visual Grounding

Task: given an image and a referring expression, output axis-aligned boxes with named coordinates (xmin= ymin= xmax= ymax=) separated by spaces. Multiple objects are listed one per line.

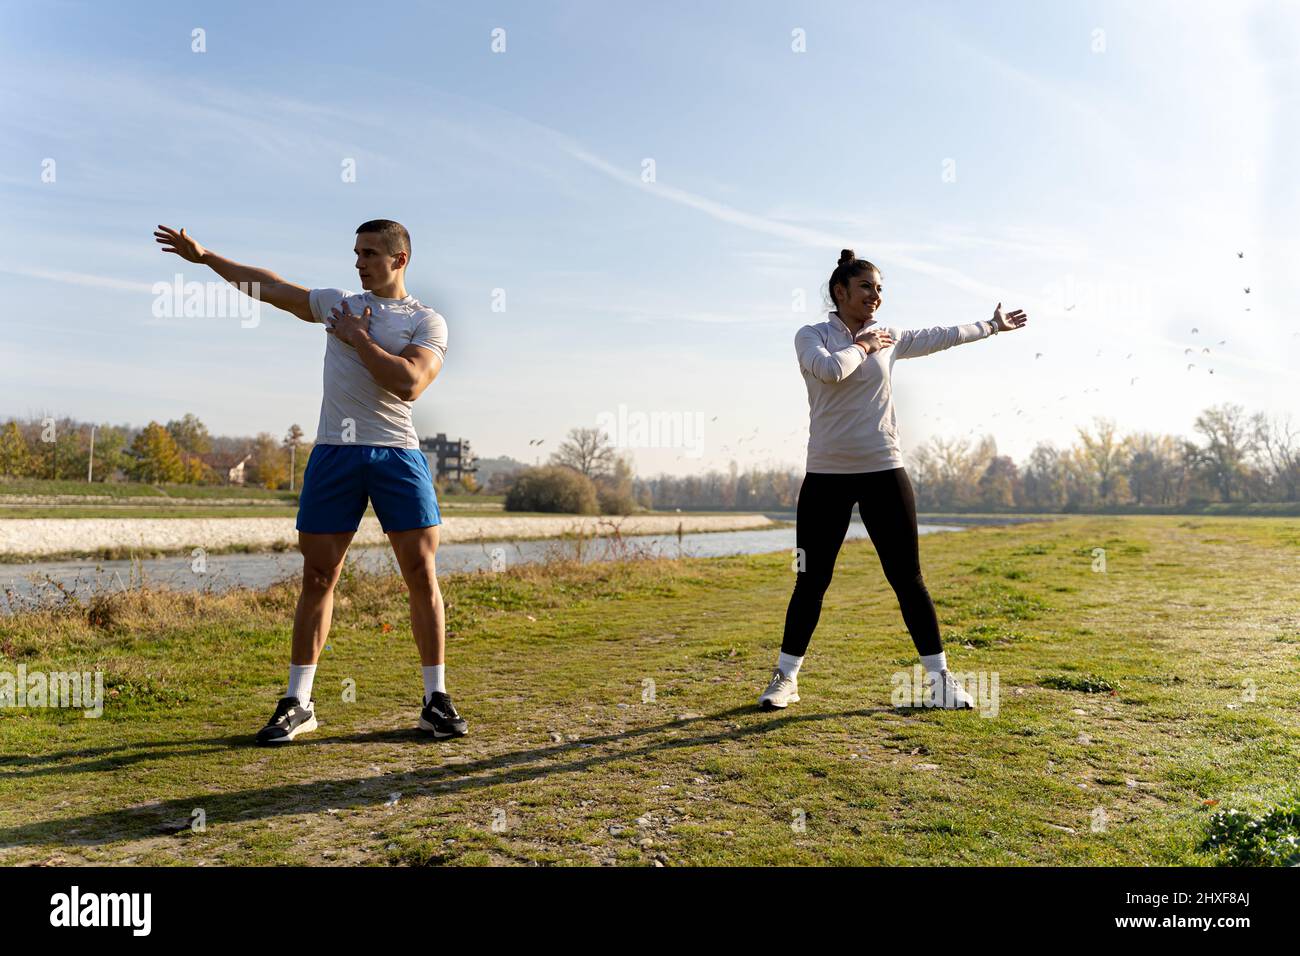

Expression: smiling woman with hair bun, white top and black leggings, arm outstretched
xmin=758 ymin=248 xmax=1028 ymax=710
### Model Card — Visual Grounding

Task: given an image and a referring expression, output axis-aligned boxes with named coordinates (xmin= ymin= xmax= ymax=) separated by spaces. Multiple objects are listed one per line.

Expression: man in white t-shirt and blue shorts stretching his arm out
xmin=153 ymin=219 xmax=468 ymax=744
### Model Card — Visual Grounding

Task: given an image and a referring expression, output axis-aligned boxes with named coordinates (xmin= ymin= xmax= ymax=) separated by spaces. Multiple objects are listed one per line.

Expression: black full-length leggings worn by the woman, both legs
xmin=781 ymin=468 xmax=944 ymax=657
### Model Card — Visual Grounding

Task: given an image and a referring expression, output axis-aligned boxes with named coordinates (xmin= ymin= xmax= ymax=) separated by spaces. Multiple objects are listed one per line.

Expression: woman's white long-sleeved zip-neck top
xmin=794 ymin=312 xmax=995 ymax=475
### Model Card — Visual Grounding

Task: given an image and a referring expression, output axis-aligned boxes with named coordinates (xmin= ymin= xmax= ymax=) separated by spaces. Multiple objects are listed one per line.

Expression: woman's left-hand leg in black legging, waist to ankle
xmin=781 ymin=473 xmax=857 ymax=657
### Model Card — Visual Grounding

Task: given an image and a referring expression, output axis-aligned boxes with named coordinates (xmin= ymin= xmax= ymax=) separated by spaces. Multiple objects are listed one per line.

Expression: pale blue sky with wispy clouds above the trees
xmin=0 ymin=0 xmax=1300 ymax=475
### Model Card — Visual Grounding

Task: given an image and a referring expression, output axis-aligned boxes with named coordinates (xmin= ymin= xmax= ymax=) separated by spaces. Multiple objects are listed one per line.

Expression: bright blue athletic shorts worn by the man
xmin=298 ymin=445 xmax=442 ymax=535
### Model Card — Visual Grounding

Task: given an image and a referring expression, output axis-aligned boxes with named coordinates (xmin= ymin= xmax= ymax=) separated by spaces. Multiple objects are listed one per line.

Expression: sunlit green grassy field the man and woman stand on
xmin=0 ymin=516 xmax=1300 ymax=865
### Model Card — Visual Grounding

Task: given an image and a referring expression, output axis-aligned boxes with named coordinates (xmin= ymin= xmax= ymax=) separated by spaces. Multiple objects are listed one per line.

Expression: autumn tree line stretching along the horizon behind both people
xmin=0 ymin=403 xmax=1300 ymax=514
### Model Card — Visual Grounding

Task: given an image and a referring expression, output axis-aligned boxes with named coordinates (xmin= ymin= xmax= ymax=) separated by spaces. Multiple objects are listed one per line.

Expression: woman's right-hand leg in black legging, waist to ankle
xmin=858 ymin=468 xmax=944 ymax=657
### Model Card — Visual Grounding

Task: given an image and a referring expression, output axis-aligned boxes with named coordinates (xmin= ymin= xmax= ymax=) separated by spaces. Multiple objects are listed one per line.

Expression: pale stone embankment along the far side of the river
xmin=0 ymin=514 xmax=774 ymax=555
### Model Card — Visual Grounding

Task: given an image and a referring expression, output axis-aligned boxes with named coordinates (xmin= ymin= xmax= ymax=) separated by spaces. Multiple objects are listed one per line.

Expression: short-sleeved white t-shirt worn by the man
xmin=311 ymin=289 xmax=447 ymax=449
